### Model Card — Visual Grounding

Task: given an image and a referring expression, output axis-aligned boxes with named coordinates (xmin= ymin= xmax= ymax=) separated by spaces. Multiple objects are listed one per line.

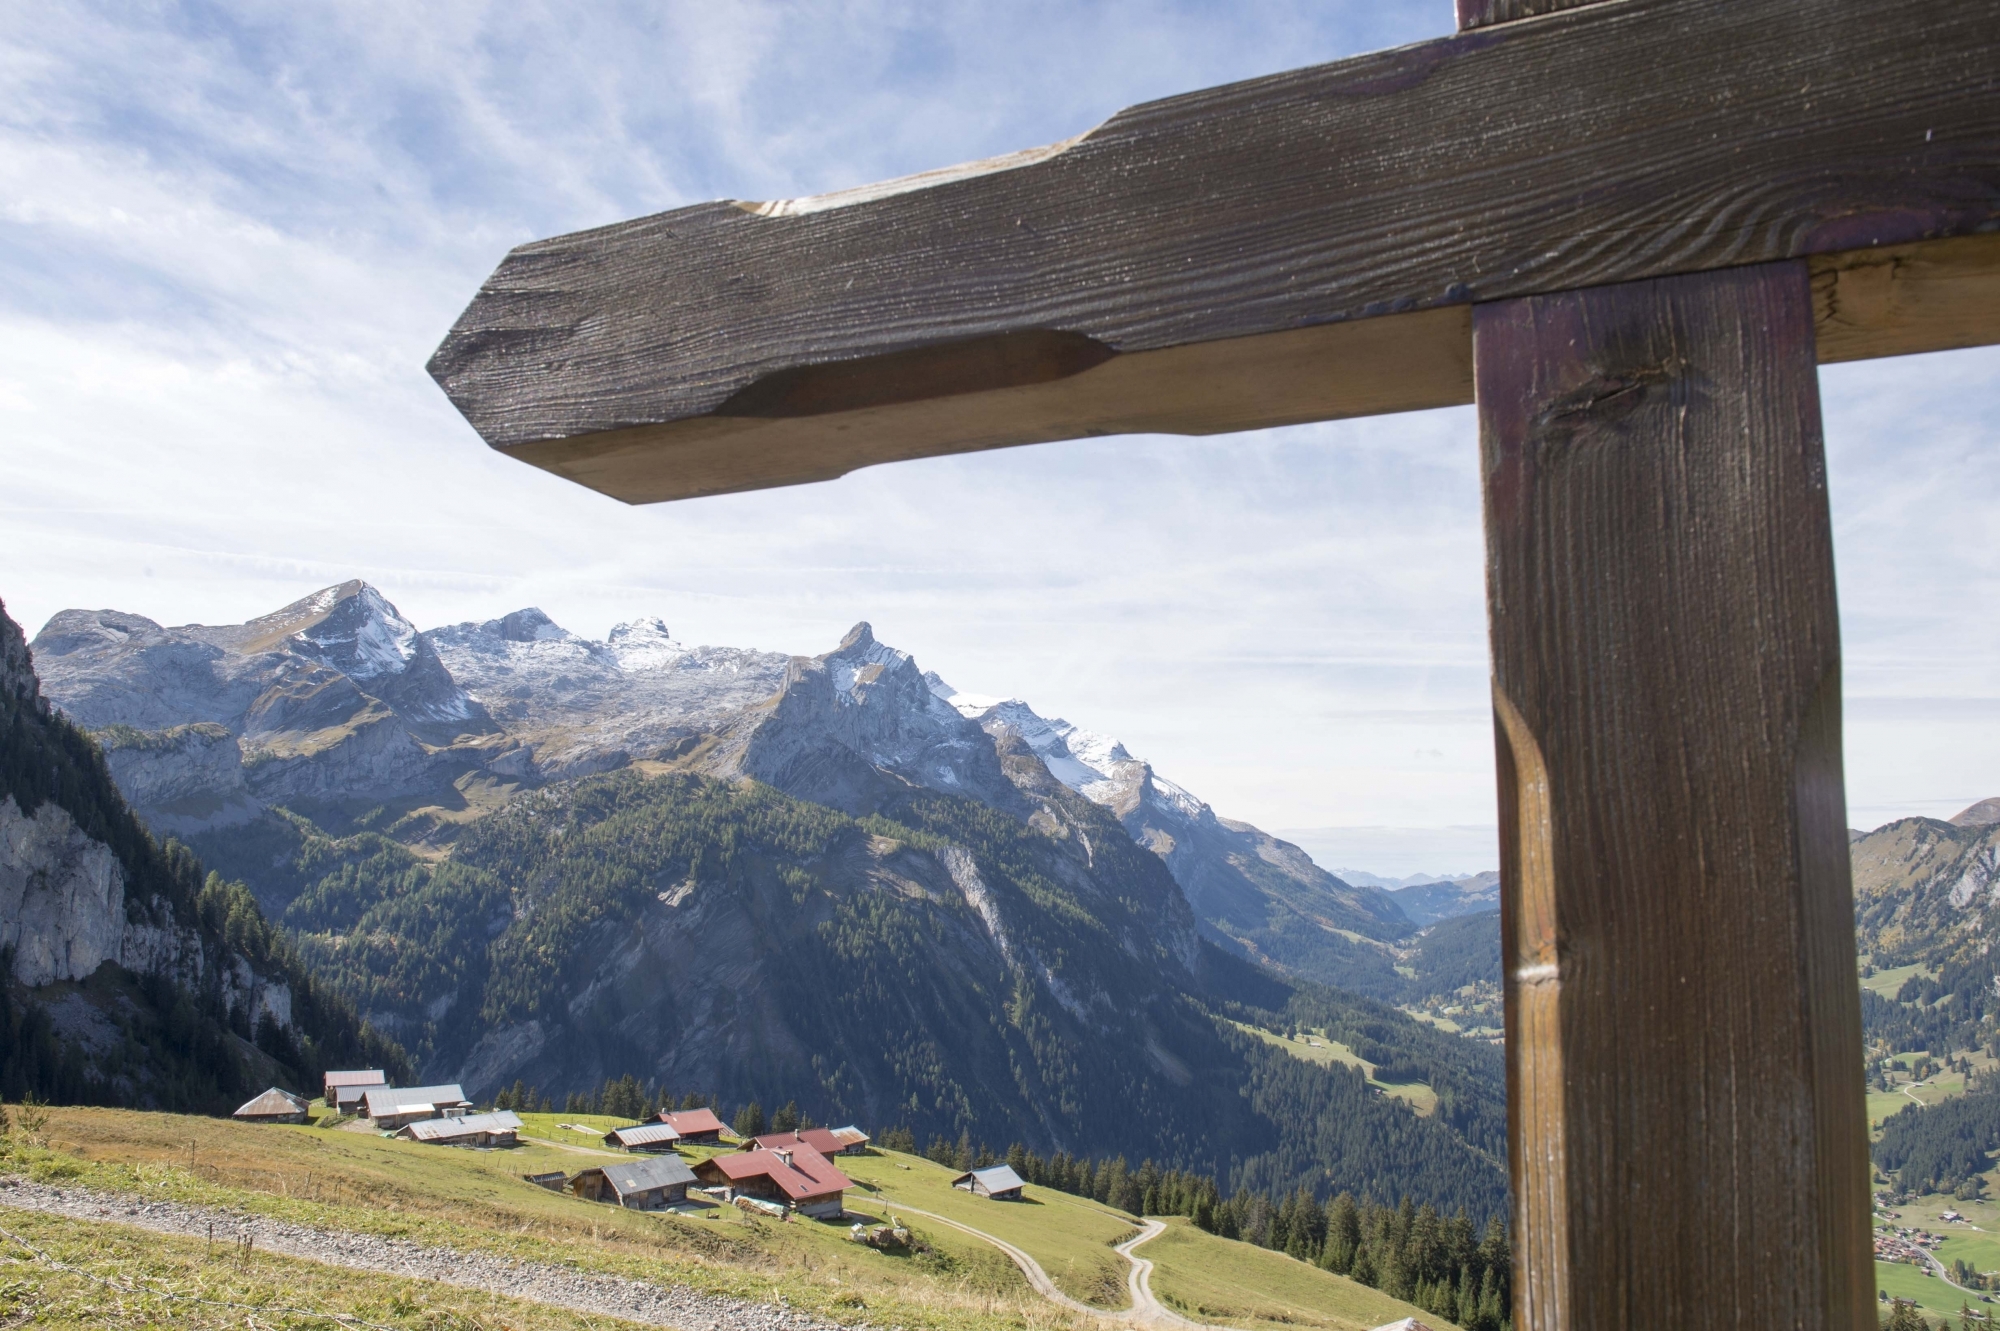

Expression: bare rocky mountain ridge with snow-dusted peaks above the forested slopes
xmin=34 ymin=582 xmax=1414 ymax=991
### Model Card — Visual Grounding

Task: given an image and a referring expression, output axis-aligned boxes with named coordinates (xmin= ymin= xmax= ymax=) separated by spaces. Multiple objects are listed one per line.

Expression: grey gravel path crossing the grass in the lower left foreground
xmin=0 ymin=1177 xmax=838 ymax=1331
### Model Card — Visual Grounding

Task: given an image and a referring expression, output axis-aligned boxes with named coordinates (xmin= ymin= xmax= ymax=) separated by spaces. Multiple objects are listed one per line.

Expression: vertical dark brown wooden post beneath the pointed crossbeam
xmin=1474 ymin=253 xmax=1876 ymax=1331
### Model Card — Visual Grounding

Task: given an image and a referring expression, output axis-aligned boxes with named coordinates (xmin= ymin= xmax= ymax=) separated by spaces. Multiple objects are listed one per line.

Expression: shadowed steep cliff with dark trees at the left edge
xmin=0 ymin=606 xmax=400 ymax=1111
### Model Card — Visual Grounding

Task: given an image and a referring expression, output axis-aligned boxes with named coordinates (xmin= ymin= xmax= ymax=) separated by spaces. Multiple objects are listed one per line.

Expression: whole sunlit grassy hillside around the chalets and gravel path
xmin=0 ymin=1109 xmax=1440 ymax=1331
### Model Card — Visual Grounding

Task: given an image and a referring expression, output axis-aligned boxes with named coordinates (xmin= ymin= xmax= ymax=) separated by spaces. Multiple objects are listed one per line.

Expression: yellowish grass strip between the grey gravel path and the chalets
xmin=23 ymin=1109 xmax=1074 ymax=1331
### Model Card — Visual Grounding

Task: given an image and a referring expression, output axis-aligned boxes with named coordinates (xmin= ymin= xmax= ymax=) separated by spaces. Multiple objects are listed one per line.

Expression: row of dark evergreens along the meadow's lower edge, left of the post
xmin=878 ymin=1127 xmax=1514 ymax=1331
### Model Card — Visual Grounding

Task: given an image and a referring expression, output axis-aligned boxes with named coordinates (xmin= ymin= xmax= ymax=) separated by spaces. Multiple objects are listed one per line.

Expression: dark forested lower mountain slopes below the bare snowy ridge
xmin=219 ymin=771 xmax=1504 ymax=1215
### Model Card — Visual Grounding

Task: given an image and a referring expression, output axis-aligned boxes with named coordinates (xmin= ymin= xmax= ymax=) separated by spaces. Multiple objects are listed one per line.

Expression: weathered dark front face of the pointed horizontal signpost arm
xmin=430 ymin=0 xmax=2000 ymax=498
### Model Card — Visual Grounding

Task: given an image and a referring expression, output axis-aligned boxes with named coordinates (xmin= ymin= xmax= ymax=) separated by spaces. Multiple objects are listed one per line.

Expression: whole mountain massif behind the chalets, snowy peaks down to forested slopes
xmin=27 ymin=588 xmax=1504 ymax=1217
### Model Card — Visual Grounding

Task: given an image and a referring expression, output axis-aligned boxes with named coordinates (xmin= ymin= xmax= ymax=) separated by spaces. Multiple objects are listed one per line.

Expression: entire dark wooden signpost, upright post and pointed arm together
xmin=430 ymin=0 xmax=2000 ymax=1331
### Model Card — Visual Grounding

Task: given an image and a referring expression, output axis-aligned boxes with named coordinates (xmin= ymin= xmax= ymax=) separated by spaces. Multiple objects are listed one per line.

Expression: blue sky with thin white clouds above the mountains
xmin=0 ymin=0 xmax=2000 ymax=875
